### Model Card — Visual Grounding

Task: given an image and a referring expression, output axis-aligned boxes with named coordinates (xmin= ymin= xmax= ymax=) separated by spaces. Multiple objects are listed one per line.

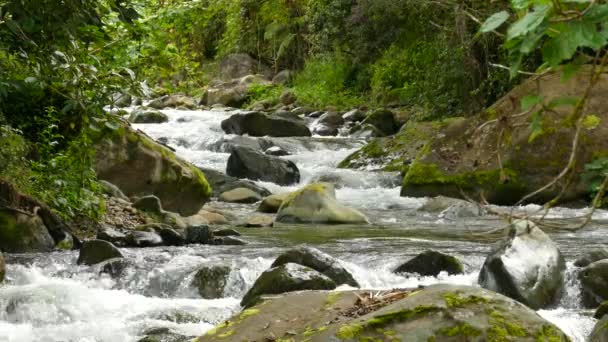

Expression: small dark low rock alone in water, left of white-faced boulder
xmin=393 ymin=250 xmax=464 ymax=277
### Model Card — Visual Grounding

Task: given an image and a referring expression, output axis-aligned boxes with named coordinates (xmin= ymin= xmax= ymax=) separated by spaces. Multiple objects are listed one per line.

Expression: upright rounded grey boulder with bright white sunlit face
xmin=479 ymin=220 xmax=566 ymax=309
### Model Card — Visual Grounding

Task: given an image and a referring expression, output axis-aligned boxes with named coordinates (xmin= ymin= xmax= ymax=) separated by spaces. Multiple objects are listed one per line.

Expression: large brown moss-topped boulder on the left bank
xmin=94 ymin=126 xmax=211 ymax=216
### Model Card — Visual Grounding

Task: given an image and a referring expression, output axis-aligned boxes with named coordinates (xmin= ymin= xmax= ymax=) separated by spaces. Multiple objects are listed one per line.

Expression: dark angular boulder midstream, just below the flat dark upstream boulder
xmin=226 ymin=147 xmax=300 ymax=185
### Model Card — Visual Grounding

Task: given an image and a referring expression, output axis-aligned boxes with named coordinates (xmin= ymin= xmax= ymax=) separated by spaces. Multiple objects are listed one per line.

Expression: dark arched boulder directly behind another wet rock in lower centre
xmin=270 ymin=247 xmax=359 ymax=287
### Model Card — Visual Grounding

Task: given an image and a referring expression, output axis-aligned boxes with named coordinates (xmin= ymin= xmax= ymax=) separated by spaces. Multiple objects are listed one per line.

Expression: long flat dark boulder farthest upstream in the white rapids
xmin=221 ymin=112 xmax=311 ymax=137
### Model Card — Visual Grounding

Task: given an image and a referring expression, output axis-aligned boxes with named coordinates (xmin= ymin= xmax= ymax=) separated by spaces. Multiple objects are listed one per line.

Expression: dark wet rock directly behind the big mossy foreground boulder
xmin=241 ymin=263 xmax=336 ymax=308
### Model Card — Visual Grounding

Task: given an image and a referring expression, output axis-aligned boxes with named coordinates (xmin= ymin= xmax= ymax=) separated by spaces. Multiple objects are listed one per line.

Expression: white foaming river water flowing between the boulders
xmin=0 ymin=110 xmax=608 ymax=342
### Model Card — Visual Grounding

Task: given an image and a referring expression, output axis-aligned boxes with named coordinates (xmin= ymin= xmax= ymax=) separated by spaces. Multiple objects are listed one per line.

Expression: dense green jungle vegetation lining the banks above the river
xmin=0 ymin=0 xmax=608 ymax=218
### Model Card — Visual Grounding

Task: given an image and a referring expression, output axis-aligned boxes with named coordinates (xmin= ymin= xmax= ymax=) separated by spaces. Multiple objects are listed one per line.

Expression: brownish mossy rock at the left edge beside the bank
xmin=0 ymin=208 xmax=55 ymax=253
